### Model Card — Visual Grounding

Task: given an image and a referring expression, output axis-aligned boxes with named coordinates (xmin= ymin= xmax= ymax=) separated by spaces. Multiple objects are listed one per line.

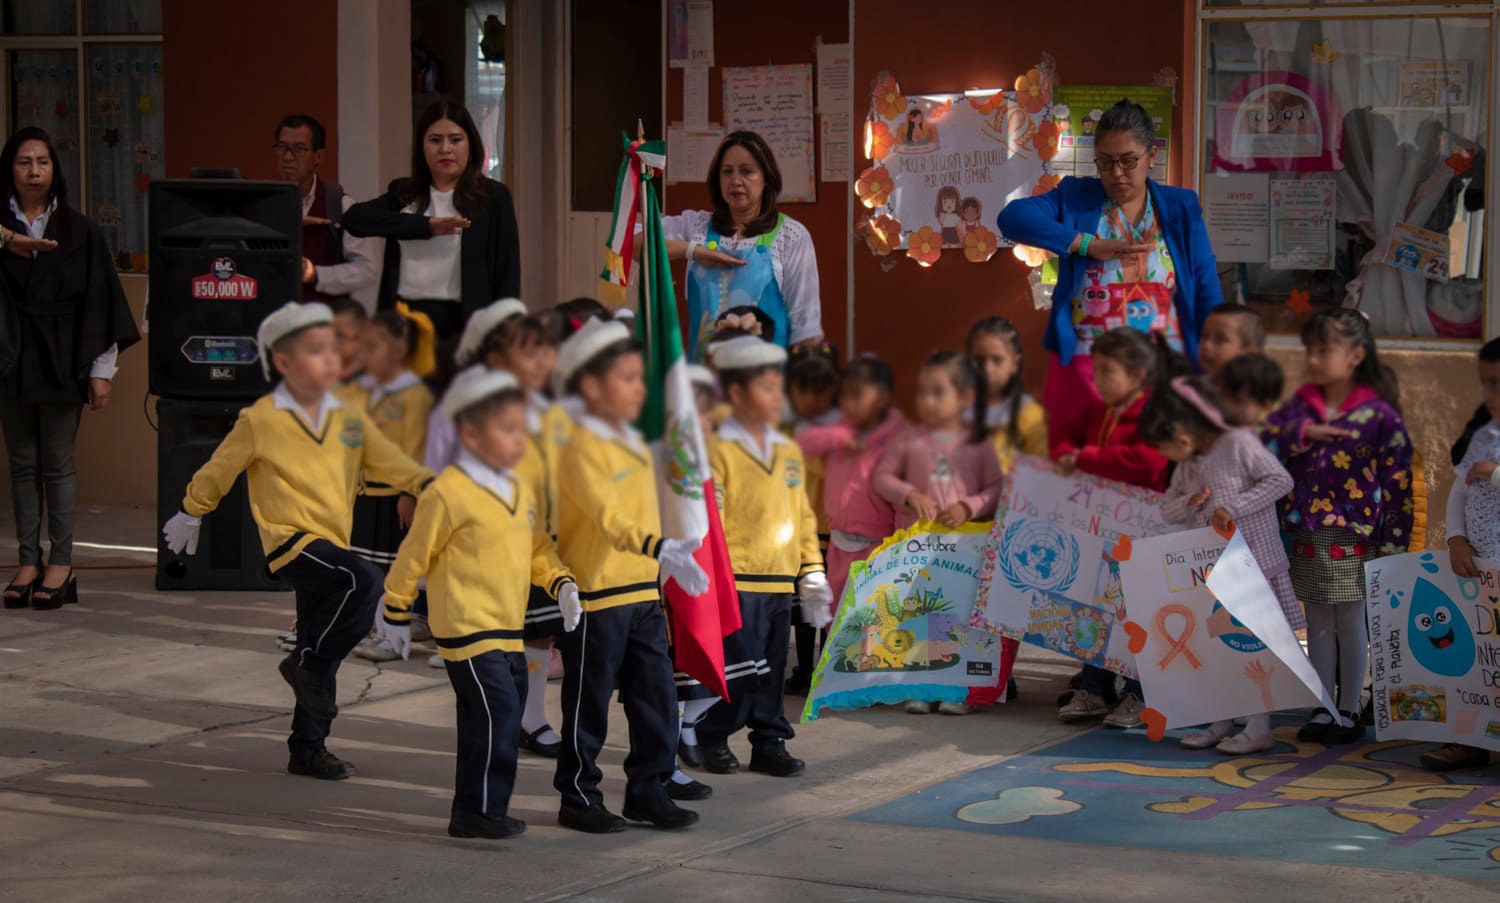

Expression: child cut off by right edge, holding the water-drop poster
xmin=1421 ymin=339 xmax=1500 ymax=771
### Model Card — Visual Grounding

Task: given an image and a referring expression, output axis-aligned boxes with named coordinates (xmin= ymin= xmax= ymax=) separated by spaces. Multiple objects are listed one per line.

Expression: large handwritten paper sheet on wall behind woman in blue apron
xmin=723 ymin=63 xmax=818 ymax=204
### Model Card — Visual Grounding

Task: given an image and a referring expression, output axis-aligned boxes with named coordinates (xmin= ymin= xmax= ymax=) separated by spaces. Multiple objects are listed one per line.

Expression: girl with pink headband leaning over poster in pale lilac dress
xmin=1140 ymin=377 xmax=1307 ymax=756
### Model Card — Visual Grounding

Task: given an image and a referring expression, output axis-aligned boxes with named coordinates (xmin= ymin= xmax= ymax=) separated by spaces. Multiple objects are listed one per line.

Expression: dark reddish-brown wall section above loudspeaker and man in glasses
xmin=162 ymin=0 xmax=342 ymax=180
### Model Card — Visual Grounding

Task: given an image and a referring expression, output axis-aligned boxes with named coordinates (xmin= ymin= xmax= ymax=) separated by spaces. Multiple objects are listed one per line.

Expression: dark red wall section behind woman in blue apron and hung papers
xmin=666 ymin=0 xmax=851 ymax=353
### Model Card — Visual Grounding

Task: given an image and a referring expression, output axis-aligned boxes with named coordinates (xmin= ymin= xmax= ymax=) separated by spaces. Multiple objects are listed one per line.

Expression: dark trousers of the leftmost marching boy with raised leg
xmin=278 ymin=540 xmax=384 ymax=752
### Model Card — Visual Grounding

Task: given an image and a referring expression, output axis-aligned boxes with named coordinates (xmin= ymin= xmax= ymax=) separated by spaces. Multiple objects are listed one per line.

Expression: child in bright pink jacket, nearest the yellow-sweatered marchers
xmin=797 ymin=356 xmax=906 ymax=612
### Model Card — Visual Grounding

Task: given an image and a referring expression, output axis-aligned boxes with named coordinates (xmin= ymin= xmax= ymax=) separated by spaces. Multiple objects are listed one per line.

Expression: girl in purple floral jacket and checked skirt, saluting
xmin=1263 ymin=308 xmax=1413 ymax=744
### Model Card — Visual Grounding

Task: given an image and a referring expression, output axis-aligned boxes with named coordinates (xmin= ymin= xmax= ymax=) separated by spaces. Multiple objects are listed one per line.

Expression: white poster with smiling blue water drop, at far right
xmin=1365 ymin=552 xmax=1500 ymax=750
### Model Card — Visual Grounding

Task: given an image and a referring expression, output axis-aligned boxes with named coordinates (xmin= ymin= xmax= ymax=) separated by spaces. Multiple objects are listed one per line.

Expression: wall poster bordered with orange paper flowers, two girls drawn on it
xmin=855 ymin=66 xmax=1061 ymax=267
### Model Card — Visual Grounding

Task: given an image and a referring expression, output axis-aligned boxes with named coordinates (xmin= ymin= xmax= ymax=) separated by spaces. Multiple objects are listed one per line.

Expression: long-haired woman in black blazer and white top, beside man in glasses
xmin=344 ymin=101 xmax=521 ymax=341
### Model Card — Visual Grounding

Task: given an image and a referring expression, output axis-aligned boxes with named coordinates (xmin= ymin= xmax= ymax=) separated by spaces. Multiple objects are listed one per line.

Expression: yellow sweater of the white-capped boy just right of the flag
xmin=708 ymin=435 xmax=824 ymax=594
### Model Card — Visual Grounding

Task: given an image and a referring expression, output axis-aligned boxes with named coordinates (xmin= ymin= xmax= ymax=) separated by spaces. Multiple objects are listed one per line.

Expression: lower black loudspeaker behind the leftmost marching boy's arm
xmin=156 ymin=398 xmax=290 ymax=591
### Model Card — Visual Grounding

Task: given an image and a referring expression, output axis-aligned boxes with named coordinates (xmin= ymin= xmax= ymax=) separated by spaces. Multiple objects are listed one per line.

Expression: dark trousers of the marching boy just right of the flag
xmin=698 ymin=593 xmax=795 ymax=749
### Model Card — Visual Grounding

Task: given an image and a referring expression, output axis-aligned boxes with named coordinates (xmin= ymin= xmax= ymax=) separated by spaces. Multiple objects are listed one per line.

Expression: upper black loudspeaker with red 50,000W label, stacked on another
xmin=147 ymin=179 xmax=302 ymax=399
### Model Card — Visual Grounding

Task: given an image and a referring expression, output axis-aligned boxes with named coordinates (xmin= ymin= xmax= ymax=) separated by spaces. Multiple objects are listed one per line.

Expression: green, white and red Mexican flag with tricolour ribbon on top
xmin=606 ymin=133 xmax=740 ymax=699
